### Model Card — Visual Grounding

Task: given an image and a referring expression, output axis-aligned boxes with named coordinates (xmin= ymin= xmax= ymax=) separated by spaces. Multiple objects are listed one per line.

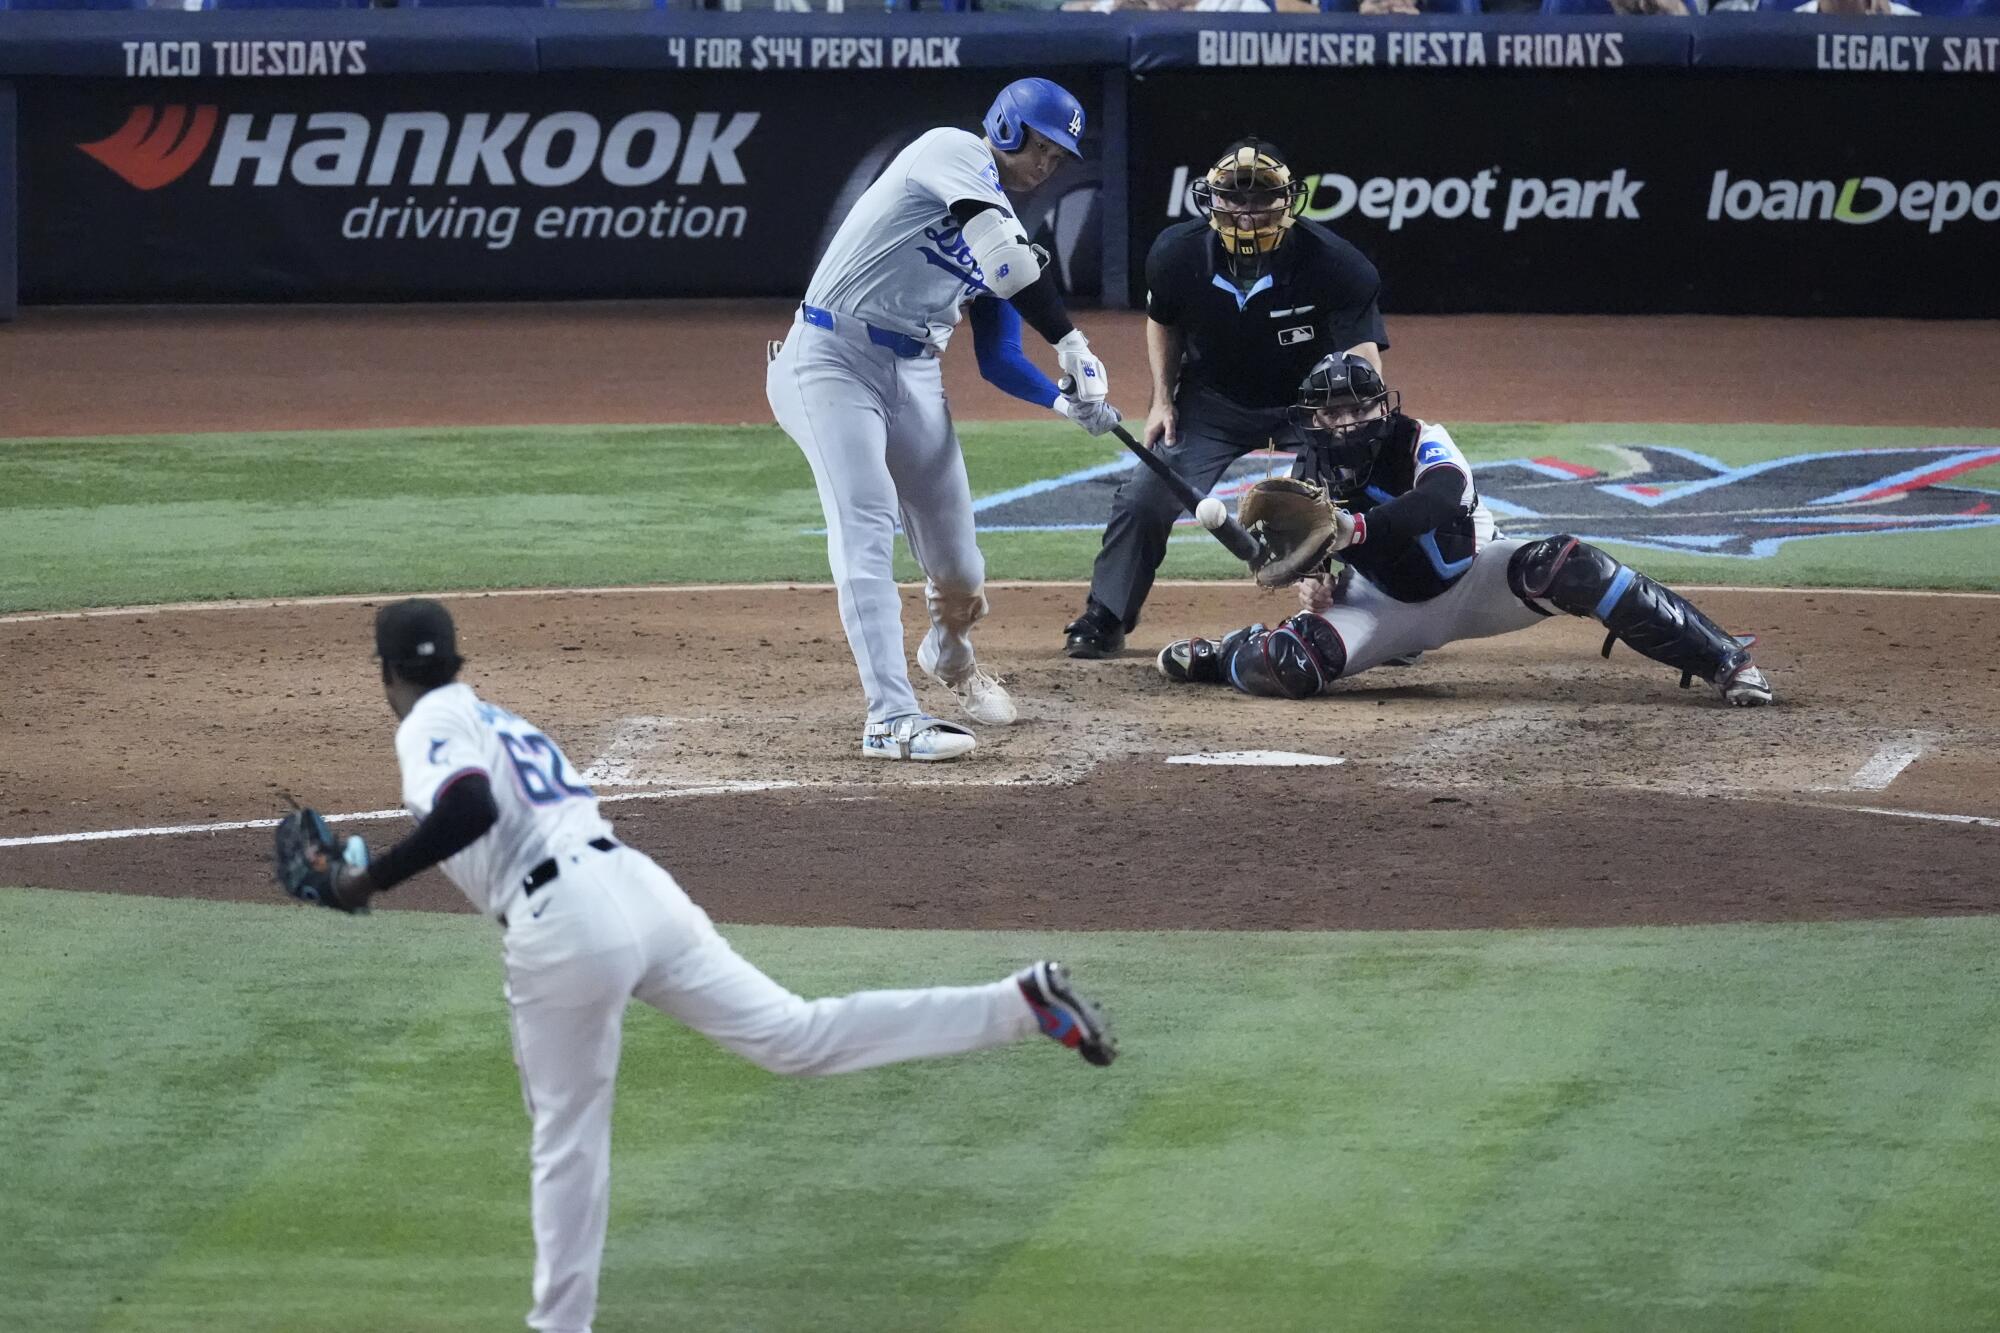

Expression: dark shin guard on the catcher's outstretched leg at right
xmin=1506 ymin=534 xmax=1750 ymax=687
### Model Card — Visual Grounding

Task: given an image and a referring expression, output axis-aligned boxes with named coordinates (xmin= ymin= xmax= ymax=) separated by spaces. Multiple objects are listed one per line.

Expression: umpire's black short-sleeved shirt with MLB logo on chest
xmin=1146 ymin=218 xmax=1388 ymax=408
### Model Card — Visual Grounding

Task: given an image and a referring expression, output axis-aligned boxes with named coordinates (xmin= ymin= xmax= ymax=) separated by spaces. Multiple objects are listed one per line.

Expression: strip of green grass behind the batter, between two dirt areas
xmin=0 ymin=422 xmax=2000 ymax=612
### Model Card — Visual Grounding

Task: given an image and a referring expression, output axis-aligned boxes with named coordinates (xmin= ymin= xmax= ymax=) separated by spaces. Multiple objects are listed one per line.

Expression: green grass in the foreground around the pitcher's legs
xmin=11 ymin=891 xmax=2000 ymax=1333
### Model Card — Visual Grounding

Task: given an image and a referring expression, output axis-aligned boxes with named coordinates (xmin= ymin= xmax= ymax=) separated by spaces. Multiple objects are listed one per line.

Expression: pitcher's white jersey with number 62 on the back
xmin=396 ymin=685 xmax=612 ymax=917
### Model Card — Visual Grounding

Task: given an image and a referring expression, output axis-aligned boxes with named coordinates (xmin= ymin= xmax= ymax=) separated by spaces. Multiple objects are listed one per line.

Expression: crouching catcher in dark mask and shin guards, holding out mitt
xmin=1158 ymin=354 xmax=1772 ymax=707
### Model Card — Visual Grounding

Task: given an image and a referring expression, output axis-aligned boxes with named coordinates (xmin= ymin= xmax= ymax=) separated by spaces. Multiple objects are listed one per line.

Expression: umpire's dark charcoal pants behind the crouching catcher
xmin=1090 ymin=386 xmax=1298 ymax=632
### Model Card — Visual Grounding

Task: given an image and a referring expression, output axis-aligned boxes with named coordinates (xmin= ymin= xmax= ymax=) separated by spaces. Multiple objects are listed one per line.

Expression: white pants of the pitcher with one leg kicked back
xmin=506 ymin=847 xmax=1038 ymax=1333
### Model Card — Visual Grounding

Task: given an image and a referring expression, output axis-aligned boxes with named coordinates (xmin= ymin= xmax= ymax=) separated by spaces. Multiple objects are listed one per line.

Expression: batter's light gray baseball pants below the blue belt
xmin=764 ymin=314 xmax=986 ymax=723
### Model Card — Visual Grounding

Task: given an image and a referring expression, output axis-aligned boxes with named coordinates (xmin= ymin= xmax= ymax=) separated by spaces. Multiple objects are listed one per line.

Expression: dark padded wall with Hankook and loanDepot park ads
xmin=0 ymin=8 xmax=2000 ymax=316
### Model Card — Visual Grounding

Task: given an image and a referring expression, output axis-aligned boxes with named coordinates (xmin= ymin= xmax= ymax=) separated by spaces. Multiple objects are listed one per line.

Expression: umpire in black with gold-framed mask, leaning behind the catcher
xmin=1062 ymin=138 xmax=1388 ymax=656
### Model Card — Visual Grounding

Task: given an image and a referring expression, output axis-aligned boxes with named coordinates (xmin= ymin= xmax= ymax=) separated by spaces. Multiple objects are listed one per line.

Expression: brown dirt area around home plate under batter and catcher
xmin=0 ymin=586 xmax=2000 ymax=929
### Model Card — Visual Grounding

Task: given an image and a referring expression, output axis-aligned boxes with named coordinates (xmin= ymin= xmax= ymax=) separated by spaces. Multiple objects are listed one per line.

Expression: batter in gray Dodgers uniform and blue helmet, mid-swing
xmin=764 ymin=78 xmax=1118 ymax=761
